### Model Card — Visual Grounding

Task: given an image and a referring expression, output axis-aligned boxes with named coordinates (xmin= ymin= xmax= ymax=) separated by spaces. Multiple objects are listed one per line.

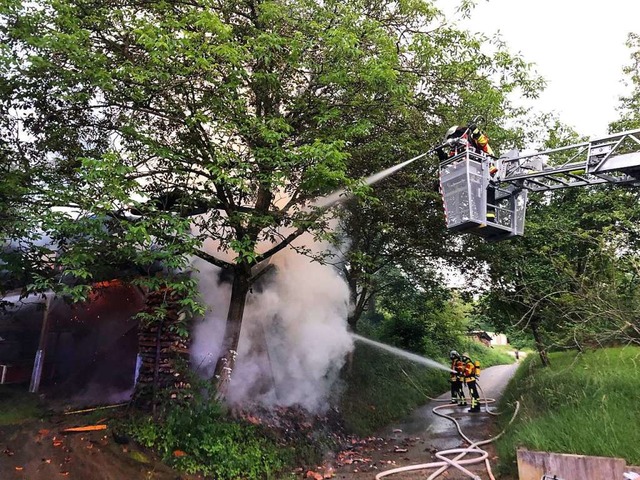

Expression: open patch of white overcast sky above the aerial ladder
xmin=440 ymin=0 xmax=640 ymax=137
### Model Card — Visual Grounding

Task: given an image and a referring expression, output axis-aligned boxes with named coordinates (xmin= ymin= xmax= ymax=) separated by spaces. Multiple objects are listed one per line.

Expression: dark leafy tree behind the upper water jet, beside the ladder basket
xmin=332 ymin=40 xmax=543 ymax=331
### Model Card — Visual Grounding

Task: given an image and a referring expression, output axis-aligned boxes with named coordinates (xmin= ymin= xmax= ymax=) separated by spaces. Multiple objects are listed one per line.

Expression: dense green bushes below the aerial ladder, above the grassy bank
xmin=482 ymin=180 xmax=640 ymax=360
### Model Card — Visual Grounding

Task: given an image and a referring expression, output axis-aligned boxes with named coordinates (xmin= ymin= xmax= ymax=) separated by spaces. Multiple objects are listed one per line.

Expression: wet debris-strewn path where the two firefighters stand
xmin=335 ymin=364 xmax=517 ymax=480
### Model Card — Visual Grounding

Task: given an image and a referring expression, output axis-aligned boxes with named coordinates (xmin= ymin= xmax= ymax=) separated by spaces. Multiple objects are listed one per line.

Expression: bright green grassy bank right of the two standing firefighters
xmin=496 ymin=347 xmax=640 ymax=474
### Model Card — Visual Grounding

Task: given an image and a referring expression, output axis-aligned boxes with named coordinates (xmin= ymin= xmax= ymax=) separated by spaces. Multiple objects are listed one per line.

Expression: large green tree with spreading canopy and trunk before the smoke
xmin=0 ymin=0 xmax=540 ymax=393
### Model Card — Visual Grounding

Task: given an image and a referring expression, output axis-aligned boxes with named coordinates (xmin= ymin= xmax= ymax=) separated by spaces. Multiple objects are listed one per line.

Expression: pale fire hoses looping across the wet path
xmin=376 ymin=373 xmax=520 ymax=480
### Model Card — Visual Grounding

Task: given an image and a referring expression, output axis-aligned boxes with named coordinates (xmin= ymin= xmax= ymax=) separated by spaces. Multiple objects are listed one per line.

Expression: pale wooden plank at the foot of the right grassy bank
xmin=517 ymin=449 xmax=626 ymax=480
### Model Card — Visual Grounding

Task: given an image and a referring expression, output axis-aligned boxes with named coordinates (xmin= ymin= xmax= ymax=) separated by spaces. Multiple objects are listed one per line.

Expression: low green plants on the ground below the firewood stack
xmin=127 ymin=403 xmax=286 ymax=480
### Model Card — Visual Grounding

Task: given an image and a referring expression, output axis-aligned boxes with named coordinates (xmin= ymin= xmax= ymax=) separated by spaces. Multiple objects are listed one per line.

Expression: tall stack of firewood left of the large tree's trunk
xmin=136 ymin=289 xmax=191 ymax=405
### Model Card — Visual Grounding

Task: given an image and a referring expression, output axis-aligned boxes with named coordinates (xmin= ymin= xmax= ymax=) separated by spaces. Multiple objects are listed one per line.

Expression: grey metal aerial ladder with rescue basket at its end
xmin=440 ymin=129 xmax=640 ymax=242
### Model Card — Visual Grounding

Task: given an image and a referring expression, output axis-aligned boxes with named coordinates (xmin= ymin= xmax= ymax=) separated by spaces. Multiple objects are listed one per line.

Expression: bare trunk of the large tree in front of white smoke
xmin=213 ymin=267 xmax=250 ymax=400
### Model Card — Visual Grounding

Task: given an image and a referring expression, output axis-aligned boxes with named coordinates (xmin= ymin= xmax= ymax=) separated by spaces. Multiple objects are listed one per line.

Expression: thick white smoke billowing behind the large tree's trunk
xmin=191 ymin=232 xmax=353 ymax=412
